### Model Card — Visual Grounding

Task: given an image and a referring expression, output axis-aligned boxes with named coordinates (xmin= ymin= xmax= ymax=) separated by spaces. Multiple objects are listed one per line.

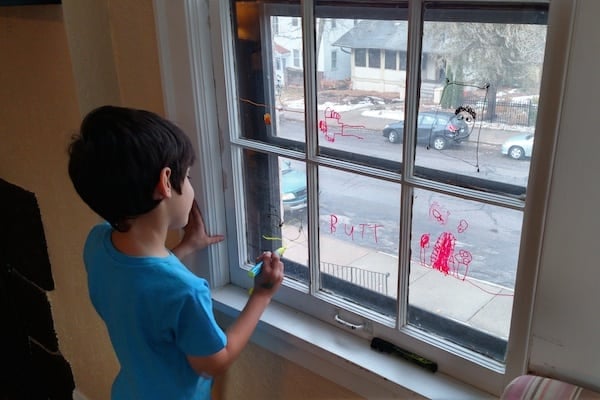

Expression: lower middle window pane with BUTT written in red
xmin=319 ymin=167 xmax=400 ymax=317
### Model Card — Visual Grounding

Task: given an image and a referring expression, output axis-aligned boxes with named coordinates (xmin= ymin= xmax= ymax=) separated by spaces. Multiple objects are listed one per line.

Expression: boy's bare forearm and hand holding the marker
xmin=187 ymin=252 xmax=283 ymax=376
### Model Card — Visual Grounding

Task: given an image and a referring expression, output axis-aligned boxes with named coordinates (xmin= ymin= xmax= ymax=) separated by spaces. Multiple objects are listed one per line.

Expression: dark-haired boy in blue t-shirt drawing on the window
xmin=69 ymin=106 xmax=283 ymax=400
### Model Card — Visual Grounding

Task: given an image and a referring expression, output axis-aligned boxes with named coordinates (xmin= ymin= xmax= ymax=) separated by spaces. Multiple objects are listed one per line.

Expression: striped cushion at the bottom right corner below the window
xmin=502 ymin=375 xmax=582 ymax=400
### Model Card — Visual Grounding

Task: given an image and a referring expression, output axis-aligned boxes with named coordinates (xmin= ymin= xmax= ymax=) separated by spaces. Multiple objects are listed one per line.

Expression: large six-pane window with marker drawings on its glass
xmin=176 ymin=0 xmax=547 ymax=394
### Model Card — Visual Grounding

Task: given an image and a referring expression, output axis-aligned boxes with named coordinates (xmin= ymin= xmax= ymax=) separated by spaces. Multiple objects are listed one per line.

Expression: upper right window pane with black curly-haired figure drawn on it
xmin=415 ymin=6 xmax=546 ymax=195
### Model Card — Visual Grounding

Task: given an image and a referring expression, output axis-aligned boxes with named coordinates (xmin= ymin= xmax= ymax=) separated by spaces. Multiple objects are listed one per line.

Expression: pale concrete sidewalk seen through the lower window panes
xmin=285 ymin=225 xmax=513 ymax=339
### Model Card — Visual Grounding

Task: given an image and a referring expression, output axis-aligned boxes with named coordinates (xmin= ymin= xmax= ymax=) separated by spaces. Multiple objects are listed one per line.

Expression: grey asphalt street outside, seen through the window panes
xmin=280 ymin=120 xmax=529 ymax=289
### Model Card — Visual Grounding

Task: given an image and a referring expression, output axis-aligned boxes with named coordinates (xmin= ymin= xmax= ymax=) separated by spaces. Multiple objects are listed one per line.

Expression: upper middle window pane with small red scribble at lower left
xmin=315 ymin=3 xmax=408 ymax=164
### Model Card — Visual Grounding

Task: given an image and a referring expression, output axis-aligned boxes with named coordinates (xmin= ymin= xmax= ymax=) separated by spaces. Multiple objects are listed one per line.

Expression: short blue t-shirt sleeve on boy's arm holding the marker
xmin=175 ymin=283 xmax=227 ymax=356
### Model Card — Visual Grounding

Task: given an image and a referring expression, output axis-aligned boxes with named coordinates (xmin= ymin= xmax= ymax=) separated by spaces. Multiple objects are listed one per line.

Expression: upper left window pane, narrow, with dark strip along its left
xmin=233 ymin=1 xmax=305 ymax=149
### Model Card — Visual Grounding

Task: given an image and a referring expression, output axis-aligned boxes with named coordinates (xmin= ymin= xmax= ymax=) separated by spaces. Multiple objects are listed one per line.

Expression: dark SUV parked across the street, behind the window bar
xmin=383 ymin=111 xmax=471 ymax=150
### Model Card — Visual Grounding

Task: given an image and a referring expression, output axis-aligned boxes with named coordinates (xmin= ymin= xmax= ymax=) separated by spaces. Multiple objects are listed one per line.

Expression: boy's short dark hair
xmin=69 ymin=106 xmax=195 ymax=232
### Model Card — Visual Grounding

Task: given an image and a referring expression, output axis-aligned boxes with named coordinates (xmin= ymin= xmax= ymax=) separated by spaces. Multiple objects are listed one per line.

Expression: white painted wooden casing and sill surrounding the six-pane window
xmin=154 ymin=0 xmax=574 ymax=397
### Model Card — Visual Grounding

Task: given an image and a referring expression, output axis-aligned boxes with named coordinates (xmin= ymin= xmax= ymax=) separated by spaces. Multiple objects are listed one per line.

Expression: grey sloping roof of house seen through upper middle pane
xmin=333 ymin=20 xmax=433 ymax=53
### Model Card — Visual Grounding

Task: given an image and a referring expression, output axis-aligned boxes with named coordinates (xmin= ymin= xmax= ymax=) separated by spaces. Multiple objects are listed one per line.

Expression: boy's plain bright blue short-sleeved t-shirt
xmin=84 ymin=224 xmax=227 ymax=400
